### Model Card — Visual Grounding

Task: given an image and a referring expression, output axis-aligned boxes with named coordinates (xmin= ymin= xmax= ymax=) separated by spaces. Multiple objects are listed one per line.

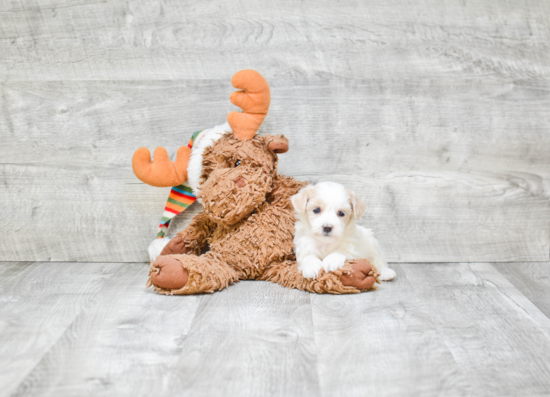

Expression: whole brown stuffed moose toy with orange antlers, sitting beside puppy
xmin=132 ymin=70 xmax=384 ymax=295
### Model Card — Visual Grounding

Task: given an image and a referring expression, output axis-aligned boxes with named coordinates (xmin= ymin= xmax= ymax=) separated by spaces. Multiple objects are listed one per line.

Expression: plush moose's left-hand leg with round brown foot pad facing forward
xmin=147 ymin=252 xmax=239 ymax=295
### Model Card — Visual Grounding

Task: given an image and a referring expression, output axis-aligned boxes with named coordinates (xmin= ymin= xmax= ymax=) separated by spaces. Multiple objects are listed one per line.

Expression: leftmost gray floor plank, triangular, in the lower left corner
xmin=0 ymin=263 xmax=121 ymax=395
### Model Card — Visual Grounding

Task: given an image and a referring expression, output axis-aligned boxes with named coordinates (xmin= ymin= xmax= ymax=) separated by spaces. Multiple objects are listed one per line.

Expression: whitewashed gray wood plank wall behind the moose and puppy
xmin=0 ymin=0 xmax=550 ymax=262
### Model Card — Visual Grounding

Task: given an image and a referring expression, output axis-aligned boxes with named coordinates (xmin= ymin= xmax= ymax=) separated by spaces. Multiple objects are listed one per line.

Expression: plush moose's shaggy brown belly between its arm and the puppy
xmin=210 ymin=204 xmax=295 ymax=279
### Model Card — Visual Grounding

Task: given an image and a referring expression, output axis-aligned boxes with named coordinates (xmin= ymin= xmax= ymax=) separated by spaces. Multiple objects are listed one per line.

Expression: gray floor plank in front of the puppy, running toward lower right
xmin=311 ymin=264 xmax=472 ymax=397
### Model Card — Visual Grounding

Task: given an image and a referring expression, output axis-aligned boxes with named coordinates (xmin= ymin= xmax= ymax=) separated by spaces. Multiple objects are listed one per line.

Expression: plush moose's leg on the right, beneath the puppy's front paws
xmin=261 ymin=259 xmax=378 ymax=294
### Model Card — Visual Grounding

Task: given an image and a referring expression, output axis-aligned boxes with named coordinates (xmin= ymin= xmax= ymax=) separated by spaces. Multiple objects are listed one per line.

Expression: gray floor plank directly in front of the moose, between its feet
xmin=163 ymin=281 xmax=321 ymax=396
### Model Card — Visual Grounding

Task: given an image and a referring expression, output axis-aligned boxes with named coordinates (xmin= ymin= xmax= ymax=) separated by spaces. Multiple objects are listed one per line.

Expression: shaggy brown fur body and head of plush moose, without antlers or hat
xmin=149 ymin=133 xmax=377 ymax=294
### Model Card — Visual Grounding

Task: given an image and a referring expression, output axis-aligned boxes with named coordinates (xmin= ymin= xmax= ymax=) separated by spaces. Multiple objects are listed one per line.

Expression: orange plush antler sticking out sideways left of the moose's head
xmin=132 ymin=146 xmax=191 ymax=187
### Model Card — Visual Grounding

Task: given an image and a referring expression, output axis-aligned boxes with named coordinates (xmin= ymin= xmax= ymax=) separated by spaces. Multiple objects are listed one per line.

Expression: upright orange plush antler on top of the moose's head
xmin=227 ymin=69 xmax=271 ymax=141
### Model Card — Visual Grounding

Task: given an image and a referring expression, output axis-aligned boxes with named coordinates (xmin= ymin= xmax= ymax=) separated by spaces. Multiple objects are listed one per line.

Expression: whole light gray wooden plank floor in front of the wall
xmin=0 ymin=262 xmax=550 ymax=396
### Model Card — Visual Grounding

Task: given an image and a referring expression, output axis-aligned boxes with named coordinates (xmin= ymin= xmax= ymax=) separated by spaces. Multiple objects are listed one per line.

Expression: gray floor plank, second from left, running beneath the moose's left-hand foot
xmin=13 ymin=263 xmax=201 ymax=396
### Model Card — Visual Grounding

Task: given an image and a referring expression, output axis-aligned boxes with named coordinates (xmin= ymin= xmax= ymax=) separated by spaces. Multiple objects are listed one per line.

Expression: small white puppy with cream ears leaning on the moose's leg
xmin=291 ymin=182 xmax=396 ymax=281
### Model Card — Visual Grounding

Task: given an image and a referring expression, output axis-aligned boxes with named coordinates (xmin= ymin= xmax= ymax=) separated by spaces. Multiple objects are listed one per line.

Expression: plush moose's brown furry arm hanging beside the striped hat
xmin=161 ymin=212 xmax=216 ymax=255
